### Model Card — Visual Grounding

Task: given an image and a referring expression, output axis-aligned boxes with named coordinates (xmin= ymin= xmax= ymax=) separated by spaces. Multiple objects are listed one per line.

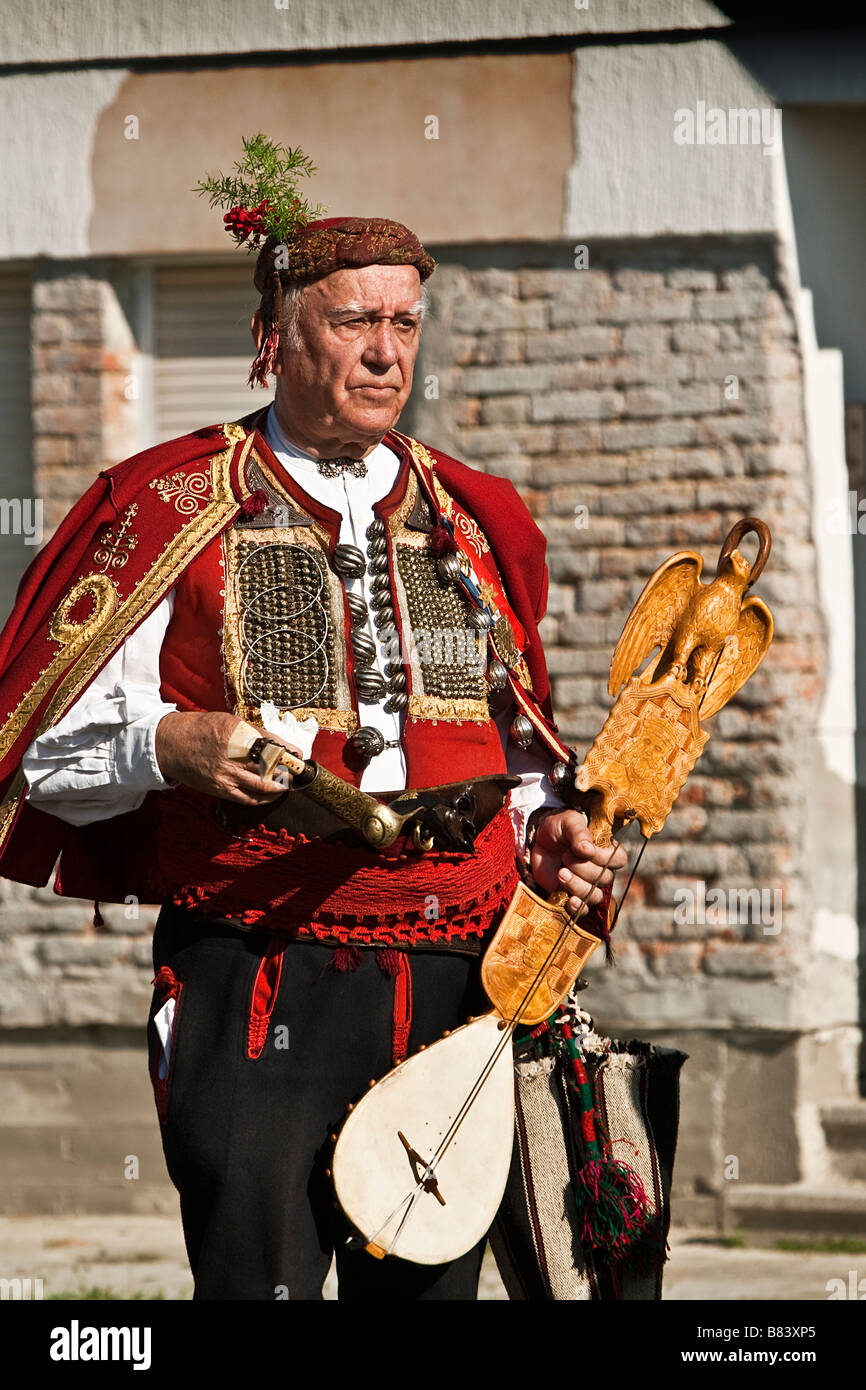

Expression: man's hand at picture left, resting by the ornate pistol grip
xmin=154 ymin=710 xmax=300 ymax=806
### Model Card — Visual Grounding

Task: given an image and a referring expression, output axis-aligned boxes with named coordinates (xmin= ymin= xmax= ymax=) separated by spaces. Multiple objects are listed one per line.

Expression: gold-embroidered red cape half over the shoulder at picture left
xmin=0 ymin=427 xmax=255 ymax=883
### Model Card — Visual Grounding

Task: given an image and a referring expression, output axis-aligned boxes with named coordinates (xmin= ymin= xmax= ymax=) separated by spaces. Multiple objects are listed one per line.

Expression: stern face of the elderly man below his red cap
xmin=269 ymin=265 xmax=421 ymax=457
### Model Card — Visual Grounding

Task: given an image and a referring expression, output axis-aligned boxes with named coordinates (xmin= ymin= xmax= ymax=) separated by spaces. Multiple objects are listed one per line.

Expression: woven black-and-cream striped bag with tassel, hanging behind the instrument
xmin=489 ymin=1002 xmax=687 ymax=1301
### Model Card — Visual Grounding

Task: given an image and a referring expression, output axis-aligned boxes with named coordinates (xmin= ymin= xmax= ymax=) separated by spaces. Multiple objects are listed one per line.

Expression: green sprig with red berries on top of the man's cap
xmin=193 ymin=131 xmax=324 ymax=250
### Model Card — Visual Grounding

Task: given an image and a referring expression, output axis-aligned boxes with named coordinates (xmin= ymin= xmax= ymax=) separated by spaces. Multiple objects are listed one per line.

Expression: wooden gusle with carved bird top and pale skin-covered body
xmin=230 ymin=517 xmax=773 ymax=1265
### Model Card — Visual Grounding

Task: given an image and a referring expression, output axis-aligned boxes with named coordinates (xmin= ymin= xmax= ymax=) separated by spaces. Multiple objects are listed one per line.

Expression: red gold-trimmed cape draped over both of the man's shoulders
xmin=0 ymin=411 xmax=569 ymax=901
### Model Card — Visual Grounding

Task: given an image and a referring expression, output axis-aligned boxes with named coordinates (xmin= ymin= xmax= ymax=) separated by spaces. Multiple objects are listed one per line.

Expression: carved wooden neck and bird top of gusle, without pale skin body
xmin=482 ymin=517 xmax=773 ymax=1027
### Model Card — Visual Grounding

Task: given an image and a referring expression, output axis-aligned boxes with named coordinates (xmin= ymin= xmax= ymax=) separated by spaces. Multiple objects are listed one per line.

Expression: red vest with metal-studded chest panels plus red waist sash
xmin=150 ymin=432 xmax=562 ymax=945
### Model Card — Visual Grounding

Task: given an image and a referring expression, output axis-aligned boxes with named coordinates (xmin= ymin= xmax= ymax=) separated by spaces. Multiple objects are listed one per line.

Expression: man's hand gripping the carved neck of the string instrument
xmin=530 ymin=810 xmax=628 ymax=917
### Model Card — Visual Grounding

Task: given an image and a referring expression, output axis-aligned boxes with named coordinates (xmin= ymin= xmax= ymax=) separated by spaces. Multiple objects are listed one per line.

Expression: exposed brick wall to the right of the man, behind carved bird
xmin=414 ymin=243 xmax=824 ymax=1024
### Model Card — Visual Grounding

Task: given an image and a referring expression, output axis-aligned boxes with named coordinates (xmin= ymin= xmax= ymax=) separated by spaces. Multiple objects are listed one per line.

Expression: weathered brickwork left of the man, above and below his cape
xmin=0 ymin=261 xmax=156 ymax=1029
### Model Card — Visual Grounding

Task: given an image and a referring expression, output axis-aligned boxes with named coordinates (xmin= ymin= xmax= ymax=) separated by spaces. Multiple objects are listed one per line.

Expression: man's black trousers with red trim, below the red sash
xmin=147 ymin=906 xmax=489 ymax=1301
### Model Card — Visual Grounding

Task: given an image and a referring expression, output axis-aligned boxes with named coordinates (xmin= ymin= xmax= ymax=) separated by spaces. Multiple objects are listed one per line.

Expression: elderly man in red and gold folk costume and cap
xmin=0 ymin=218 xmax=624 ymax=1300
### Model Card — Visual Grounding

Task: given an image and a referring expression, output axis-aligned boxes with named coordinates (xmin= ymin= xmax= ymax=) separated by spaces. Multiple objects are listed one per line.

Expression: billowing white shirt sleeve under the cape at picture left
xmin=21 ymin=591 xmax=177 ymax=826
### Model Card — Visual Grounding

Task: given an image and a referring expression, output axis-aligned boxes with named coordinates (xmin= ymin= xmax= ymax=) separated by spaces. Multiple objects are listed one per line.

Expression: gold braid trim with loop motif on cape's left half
xmin=0 ymin=425 xmax=253 ymax=848
